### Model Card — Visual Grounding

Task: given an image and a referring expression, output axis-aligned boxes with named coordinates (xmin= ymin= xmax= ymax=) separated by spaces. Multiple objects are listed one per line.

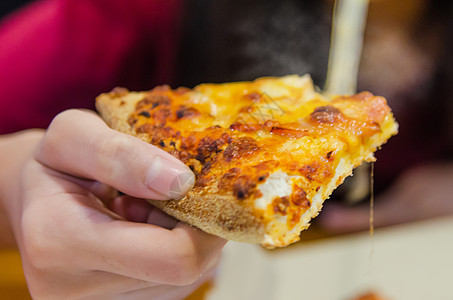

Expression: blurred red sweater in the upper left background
xmin=0 ymin=0 xmax=182 ymax=134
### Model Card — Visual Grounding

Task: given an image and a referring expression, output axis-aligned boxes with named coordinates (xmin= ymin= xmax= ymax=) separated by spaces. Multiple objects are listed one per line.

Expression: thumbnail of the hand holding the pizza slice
xmin=145 ymin=156 xmax=195 ymax=200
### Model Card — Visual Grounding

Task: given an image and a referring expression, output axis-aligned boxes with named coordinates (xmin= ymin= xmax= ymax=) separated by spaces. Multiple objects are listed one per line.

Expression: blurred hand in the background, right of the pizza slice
xmin=318 ymin=163 xmax=453 ymax=233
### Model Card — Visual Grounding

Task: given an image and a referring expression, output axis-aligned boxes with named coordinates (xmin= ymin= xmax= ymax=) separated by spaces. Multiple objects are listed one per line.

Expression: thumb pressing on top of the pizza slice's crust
xmin=35 ymin=110 xmax=195 ymax=200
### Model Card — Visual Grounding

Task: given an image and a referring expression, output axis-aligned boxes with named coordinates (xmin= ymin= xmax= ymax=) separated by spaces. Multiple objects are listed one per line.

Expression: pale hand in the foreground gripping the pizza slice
xmin=0 ymin=110 xmax=225 ymax=299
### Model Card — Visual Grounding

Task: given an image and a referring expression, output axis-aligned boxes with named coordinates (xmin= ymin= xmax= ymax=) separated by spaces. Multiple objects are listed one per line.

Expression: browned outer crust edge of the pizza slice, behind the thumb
xmin=96 ymin=91 xmax=265 ymax=244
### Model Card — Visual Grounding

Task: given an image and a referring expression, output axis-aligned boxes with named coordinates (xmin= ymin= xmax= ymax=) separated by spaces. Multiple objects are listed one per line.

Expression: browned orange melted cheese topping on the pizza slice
xmin=119 ymin=77 xmax=390 ymax=227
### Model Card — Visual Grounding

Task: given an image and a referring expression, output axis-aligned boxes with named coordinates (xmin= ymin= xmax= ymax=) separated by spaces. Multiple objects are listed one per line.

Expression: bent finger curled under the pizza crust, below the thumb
xmin=91 ymin=221 xmax=226 ymax=285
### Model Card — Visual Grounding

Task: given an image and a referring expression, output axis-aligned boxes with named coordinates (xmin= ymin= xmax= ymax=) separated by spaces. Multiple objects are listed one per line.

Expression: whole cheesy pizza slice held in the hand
xmin=96 ymin=75 xmax=398 ymax=248
